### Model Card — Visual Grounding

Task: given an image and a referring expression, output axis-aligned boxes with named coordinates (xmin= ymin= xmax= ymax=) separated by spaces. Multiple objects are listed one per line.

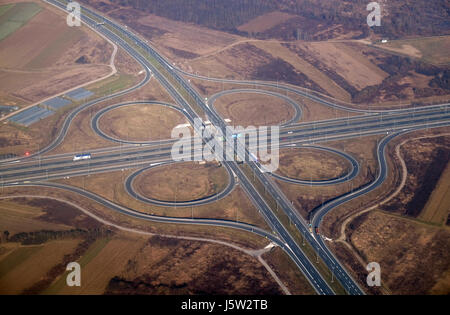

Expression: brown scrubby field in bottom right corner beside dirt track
xmin=347 ymin=211 xmax=450 ymax=294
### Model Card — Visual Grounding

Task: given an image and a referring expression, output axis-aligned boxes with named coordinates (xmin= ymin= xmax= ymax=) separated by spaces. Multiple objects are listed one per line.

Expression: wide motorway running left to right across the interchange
xmin=0 ymin=109 xmax=450 ymax=182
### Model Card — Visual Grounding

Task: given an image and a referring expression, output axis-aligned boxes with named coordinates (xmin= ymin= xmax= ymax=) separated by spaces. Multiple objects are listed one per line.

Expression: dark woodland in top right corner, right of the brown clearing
xmin=277 ymin=0 xmax=450 ymax=38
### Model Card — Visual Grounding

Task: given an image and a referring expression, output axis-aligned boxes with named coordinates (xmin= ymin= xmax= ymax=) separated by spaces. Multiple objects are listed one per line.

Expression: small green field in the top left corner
xmin=0 ymin=2 xmax=41 ymax=40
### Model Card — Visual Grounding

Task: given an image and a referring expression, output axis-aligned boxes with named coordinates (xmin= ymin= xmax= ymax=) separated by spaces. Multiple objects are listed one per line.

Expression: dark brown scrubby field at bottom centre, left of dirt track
xmin=106 ymin=237 xmax=281 ymax=294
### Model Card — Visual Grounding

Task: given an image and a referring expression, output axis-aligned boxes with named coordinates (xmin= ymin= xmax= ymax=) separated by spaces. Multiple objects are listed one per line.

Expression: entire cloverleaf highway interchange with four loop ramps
xmin=0 ymin=0 xmax=450 ymax=295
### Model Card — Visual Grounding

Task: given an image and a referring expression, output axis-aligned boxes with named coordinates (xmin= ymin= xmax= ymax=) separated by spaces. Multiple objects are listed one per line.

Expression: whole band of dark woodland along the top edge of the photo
xmin=84 ymin=0 xmax=450 ymax=40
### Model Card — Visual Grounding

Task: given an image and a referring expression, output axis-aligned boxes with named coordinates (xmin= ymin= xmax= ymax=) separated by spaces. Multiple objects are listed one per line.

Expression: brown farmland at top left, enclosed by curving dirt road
xmin=0 ymin=1 xmax=113 ymax=113
